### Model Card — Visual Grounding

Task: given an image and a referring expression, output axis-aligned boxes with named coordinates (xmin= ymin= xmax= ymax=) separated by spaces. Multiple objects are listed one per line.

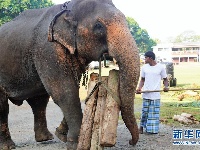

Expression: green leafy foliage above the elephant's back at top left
xmin=0 ymin=0 xmax=53 ymax=25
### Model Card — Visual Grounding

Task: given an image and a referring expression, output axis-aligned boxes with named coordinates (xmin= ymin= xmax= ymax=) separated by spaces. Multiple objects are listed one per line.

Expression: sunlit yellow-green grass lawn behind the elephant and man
xmin=80 ymin=63 xmax=200 ymax=126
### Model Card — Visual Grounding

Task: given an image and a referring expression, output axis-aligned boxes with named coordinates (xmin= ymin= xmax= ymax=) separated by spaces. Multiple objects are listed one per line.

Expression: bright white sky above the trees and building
xmin=52 ymin=0 xmax=200 ymax=42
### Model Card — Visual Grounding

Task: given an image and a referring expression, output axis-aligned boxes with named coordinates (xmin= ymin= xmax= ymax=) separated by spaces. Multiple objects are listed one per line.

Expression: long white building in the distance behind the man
xmin=153 ymin=43 xmax=200 ymax=63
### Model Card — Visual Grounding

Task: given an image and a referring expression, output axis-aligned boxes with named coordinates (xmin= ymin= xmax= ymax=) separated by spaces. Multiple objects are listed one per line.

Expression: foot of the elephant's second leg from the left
xmin=35 ymin=130 xmax=53 ymax=142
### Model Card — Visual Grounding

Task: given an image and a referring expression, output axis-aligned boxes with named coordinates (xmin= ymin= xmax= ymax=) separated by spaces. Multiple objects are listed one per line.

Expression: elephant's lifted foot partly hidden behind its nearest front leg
xmin=55 ymin=118 xmax=69 ymax=142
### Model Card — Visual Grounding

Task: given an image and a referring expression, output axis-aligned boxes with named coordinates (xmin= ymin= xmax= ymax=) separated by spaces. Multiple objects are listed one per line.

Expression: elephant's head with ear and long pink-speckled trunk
xmin=48 ymin=0 xmax=140 ymax=145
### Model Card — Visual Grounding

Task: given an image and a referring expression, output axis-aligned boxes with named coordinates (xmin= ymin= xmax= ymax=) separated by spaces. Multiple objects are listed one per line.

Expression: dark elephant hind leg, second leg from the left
xmin=27 ymin=94 xmax=53 ymax=142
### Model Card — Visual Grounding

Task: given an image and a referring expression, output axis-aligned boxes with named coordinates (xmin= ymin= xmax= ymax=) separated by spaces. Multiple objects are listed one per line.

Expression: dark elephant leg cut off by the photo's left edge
xmin=0 ymin=89 xmax=15 ymax=150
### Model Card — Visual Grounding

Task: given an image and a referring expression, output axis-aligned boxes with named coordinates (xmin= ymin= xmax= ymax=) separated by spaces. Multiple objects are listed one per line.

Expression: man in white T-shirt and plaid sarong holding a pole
xmin=136 ymin=51 xmax=169 ymax=134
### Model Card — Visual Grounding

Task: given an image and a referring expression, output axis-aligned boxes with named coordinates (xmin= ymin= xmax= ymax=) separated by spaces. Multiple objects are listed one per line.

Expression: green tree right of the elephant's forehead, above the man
xmin=126 ymin=17 xmax=156 ymax=53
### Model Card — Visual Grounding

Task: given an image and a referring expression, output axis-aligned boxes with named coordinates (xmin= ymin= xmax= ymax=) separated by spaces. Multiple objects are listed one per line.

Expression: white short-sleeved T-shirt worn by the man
xmin=141 ymin=64 xmax=167 ymax=100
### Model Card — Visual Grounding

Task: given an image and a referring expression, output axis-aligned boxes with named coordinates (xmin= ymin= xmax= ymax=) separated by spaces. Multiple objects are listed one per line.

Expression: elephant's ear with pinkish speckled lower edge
xmin=48 ymin=10 xmax=77 ymax=54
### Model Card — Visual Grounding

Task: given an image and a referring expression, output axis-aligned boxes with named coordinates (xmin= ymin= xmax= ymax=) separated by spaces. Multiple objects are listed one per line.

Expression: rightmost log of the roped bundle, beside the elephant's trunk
xmin=100 ymin=70 xmax=120 ymax=147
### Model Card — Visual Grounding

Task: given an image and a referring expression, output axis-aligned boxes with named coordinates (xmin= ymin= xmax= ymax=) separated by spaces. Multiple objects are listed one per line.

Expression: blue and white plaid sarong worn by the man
xmin=140 ymin=99 xmax=160 ymax=133
